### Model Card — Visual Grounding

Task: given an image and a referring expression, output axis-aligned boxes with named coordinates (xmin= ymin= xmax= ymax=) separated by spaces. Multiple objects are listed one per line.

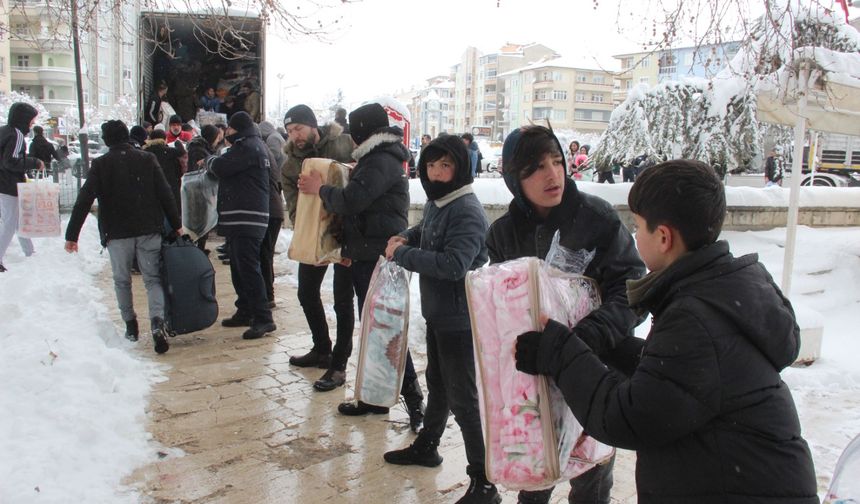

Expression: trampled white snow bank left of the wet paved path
xmin=0 ymin=217 xmax=161 ymax=503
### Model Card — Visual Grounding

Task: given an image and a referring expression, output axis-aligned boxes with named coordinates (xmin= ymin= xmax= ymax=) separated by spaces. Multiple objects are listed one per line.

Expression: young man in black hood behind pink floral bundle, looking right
xmin=487 ymin=126 xmax=645 ymax=504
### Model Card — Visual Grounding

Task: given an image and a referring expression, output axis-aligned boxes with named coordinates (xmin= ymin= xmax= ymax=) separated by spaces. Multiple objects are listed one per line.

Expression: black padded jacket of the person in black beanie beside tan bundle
xmin=320 ymin=126 xmax=409 ymax=262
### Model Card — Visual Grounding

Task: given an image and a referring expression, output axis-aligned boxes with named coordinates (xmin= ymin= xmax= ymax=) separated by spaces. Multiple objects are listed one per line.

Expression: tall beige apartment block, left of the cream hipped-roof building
xmin=452 ymin=44 xmax=558 ymax=139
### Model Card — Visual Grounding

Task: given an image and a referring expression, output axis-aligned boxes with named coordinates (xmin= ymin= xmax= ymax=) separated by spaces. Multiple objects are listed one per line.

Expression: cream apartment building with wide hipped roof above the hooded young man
xmin=500 ymin=57 xmax=615 ymax=134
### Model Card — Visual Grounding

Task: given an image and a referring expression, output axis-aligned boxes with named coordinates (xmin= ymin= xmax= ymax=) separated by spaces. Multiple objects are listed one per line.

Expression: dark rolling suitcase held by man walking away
xmin=161 ymin=236 xmax=218 ymax=334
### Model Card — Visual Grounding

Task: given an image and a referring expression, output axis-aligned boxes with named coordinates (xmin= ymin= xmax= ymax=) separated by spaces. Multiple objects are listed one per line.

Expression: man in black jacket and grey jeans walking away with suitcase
xmin=65 ymin=121 xmax=182 ymax=353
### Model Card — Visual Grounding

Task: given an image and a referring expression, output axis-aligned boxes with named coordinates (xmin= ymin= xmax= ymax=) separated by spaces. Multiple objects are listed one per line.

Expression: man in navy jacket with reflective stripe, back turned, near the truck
xmin=206 ymin=112 xmax=276 ymax=339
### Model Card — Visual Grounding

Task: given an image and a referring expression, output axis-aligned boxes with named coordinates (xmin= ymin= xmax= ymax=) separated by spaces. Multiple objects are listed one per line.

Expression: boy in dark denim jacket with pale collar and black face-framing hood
xmin=385 ymin=135 xmax=502 ymax=503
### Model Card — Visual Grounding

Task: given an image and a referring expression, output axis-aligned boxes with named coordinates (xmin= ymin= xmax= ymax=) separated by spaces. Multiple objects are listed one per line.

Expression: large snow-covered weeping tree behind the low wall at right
xmin=592 ymin=0 xmax=860 ymax=171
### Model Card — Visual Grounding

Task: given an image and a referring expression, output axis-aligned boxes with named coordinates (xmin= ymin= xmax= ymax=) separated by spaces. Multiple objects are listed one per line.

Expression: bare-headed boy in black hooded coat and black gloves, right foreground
xmin=516 ymin=160 xmax=818 ymax=504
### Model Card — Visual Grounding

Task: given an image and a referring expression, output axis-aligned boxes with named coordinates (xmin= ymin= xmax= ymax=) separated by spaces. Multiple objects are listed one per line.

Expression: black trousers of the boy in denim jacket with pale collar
xmin=421 ymin=323 xmax=484 ymax=476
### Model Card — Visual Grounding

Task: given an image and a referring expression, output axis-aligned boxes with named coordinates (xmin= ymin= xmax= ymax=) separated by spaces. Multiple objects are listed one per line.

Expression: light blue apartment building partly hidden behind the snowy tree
xmin=614 ymin=42 xmax=740 ymax=103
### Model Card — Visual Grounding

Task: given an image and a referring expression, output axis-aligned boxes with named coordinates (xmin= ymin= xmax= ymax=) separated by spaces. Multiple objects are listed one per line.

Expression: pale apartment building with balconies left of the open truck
xmin=7 ymin=0 xmax=140 ymax=117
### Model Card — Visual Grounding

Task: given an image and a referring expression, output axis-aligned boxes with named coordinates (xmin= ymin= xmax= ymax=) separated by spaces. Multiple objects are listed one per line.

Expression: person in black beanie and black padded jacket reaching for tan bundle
xmin=298 ymin=103 xmax=424 ymax=432
